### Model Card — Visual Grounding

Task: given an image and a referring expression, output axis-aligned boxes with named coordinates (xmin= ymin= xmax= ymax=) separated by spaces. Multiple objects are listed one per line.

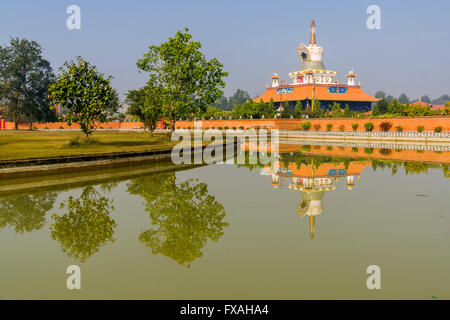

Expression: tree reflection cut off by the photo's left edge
xmin=0 ymin=192 xmax=57 ymax=233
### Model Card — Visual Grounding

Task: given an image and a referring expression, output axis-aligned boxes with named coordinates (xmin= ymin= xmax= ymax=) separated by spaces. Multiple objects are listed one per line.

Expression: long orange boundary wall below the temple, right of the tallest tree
xmin=175 ymin=116 xmax=450 ymax=131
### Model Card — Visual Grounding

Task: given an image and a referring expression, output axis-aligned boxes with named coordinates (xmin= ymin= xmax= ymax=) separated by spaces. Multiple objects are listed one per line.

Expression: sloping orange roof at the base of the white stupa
xmin=254 ymin=84 xmax=378 ymax=102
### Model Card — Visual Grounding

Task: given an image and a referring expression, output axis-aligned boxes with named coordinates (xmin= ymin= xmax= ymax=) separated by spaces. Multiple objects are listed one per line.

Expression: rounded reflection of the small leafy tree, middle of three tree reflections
xmin=50 ymin=186 xmax=117 ymax=262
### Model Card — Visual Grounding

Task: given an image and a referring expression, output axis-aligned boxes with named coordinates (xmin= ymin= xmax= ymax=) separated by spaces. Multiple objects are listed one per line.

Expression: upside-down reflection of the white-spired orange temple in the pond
xmin=263 ymin=160 xmax=370 ymax=239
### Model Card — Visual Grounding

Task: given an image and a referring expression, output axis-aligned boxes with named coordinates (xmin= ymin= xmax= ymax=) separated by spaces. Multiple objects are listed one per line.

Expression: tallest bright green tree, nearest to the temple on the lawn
xmin=137 ymin=28 xmax=228 ymax=131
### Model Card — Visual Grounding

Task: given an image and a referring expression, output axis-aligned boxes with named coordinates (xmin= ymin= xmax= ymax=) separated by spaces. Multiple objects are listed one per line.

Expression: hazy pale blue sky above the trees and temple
xmin=0 ymin=0 xmax=450 ymax=98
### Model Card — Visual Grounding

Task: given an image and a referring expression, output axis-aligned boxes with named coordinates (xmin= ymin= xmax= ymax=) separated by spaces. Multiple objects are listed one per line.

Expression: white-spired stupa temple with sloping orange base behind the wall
xmin=254 ymin=20 xmax=378 ymax=111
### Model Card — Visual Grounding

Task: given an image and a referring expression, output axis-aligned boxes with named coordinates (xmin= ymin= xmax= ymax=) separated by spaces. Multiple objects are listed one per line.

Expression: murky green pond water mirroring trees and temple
xmin=0 ymin=149 xmax=450 ymax=299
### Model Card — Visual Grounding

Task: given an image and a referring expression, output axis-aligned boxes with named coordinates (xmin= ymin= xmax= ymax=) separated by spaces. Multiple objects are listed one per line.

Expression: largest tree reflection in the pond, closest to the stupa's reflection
xmin=128 ymin=173 xmax=228 ymax=268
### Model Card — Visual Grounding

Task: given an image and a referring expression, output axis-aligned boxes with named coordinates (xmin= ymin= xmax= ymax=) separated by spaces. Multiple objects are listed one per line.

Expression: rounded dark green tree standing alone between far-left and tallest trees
xmin=49 ymin=57 xmax=114 ymax=139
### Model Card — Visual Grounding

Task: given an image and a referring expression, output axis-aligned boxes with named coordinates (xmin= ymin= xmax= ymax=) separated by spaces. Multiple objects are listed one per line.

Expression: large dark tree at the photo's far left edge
xmin=0 ymin=38 xmax=56 ymax=130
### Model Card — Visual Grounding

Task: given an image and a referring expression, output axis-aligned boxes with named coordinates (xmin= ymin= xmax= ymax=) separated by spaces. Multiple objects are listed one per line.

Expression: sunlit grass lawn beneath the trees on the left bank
xmin=0 ymin=131 xmax=177 ymax=160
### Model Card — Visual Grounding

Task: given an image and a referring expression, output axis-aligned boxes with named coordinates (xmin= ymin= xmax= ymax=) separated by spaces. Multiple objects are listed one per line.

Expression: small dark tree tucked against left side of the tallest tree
xmin=126 ymin=84 xmax=163 ymax=132
